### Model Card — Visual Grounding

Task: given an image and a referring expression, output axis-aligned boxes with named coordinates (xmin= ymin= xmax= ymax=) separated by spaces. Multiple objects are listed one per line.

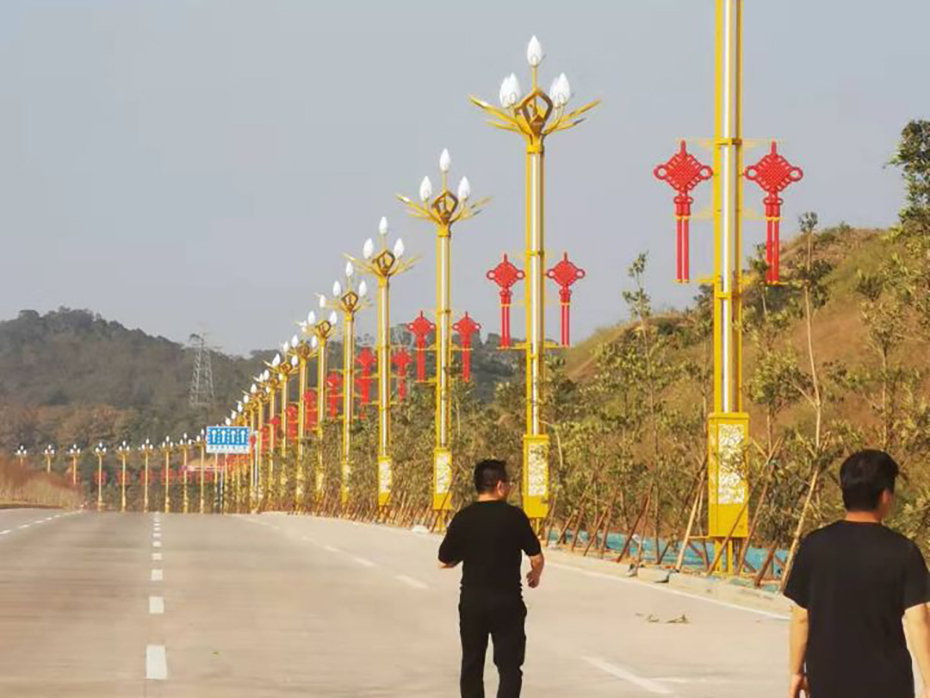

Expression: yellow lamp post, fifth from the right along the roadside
xmin=332 ymin=261 xmax=368 ymax=507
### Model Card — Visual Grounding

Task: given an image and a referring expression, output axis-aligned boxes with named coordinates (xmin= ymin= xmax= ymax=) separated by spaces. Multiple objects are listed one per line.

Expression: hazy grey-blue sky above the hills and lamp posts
xmin=0 ymin=0 xmax=930 ymax=352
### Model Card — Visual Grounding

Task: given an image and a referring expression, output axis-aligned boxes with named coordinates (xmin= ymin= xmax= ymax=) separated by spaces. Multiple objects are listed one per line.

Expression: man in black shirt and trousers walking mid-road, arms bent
xmin=439 ymin=460 xmax=544 ymax=698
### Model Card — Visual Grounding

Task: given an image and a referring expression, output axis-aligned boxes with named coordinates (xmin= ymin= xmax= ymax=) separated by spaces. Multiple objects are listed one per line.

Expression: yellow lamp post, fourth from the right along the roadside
xmin=350 ymin=218 xmax=416 ymax=507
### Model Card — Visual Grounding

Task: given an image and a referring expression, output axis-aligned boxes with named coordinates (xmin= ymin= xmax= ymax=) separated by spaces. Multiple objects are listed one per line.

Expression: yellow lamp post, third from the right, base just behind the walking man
xmin=398 ymin=150 xmax=487 ymax=511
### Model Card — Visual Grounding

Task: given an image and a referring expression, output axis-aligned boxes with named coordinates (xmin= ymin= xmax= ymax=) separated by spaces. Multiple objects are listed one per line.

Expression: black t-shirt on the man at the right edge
xmin=785 ymin=521 xmax=930 ymax=698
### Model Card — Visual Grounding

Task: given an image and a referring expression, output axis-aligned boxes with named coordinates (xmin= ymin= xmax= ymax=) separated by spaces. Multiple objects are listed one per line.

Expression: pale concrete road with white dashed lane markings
xmin=0 ymin=510 xmax=787 ymax=698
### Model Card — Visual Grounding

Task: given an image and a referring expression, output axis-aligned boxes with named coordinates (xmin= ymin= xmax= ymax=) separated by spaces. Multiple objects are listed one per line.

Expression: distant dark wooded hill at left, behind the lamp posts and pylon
xmin=0 ymin=308 xmax=512 ymax=453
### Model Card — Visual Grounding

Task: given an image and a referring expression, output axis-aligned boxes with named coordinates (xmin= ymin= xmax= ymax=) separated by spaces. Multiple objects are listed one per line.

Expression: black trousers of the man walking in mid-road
xmin=459 ymin=592 xmax=526 ymax=698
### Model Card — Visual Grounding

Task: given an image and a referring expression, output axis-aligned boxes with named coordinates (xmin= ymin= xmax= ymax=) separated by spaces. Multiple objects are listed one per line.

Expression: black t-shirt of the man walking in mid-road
xmin=439 ymin=501 xmax=542 ymax=595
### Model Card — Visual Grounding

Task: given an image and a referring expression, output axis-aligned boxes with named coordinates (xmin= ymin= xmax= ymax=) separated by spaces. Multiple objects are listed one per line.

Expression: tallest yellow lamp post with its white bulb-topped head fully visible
xmin=471 ymin=36 xmax=598 ymax=522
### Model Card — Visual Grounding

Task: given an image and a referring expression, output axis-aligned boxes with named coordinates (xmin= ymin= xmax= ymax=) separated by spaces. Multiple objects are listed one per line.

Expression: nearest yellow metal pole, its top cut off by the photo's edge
xmin=708 ymin=0 xmax=749 ymax=556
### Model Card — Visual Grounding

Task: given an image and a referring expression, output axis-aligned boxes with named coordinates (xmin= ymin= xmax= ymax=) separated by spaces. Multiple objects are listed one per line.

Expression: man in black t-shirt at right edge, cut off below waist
xmin=785 ymin=450 xmax=930 ymax=698
